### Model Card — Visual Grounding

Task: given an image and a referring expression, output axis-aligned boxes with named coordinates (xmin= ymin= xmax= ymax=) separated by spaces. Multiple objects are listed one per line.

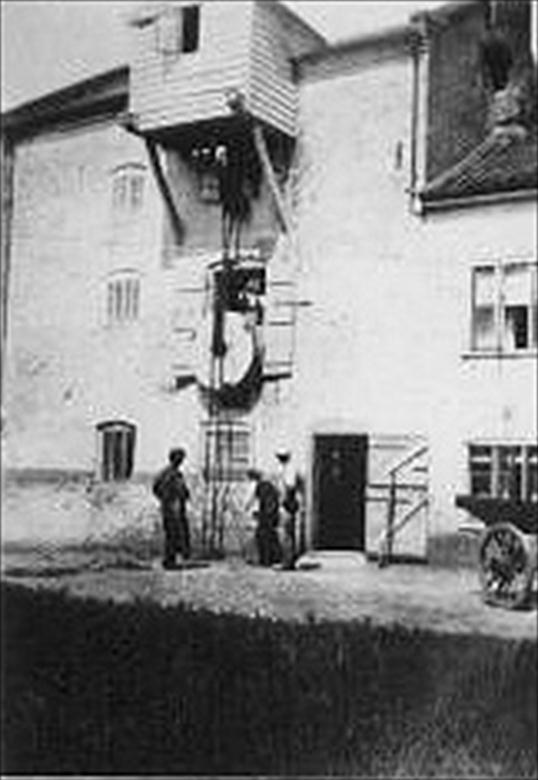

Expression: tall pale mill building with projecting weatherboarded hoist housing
xmin=2 ymin=0 xmax=538 ymax=560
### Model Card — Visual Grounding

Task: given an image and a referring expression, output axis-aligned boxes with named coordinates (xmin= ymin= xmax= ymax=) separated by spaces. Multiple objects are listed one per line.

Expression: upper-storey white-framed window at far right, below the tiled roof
xmin=471 ymin=262 xmax=538 ymax=353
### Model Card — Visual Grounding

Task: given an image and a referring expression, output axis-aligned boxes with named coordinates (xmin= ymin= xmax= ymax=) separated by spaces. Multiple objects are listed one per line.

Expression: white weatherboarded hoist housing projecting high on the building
xmin=129 ymin=0 xmax=323 ymax=137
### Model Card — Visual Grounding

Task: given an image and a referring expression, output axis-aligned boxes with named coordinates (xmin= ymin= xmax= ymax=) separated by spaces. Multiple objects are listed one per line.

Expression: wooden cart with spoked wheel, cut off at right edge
xmin=456 ymin=496 xmax=538 ymax=609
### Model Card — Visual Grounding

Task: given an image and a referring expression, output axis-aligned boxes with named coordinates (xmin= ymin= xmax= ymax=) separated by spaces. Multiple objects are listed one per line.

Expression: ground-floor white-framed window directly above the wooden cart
xmin=469 ymin=444 xmax=538 ymax=503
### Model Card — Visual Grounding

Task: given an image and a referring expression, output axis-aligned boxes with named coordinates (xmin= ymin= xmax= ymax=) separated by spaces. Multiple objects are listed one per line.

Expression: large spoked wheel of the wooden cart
xmin=479 ymin=523 xmax=534 ymax=609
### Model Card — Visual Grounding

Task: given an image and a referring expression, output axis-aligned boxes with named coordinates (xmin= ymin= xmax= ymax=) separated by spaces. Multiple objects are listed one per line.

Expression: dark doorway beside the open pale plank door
xmin=314 ymin=435 xmax=368 ymax=550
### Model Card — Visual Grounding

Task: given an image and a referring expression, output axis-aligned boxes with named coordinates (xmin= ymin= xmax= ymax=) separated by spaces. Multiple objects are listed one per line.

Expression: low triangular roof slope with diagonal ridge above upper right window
xmin=421 ymin=125 xmax=538 ymax=206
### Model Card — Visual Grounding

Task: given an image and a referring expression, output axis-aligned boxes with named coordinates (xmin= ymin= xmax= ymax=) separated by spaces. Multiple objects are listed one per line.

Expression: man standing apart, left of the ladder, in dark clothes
xmin=153 ymin=448 xmax=191 ymax=569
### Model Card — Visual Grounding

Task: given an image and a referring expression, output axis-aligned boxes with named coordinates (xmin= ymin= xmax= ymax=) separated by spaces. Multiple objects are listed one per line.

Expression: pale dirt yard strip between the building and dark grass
xmin=2 ymin=550 xmax=538 ymax=639
